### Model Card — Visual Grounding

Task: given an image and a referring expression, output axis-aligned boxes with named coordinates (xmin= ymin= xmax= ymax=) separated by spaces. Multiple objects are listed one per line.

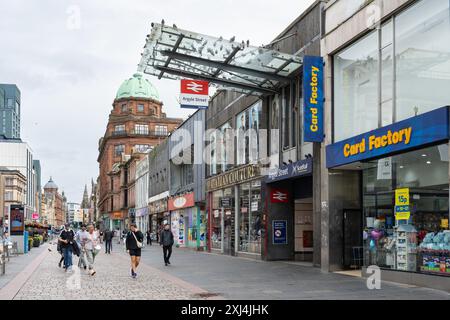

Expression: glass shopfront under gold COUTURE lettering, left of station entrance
xmin=206 ymin=165 xmax=266 ymax=258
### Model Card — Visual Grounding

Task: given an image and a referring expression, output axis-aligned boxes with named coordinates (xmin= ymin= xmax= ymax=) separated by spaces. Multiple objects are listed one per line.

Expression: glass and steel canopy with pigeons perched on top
xmin=138 ymin=23 xmax=303 ymax=95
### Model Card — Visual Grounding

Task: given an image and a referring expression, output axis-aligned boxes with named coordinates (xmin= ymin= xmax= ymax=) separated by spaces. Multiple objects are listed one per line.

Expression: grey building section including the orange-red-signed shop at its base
xmin=169 ymin=110 xmax=207 ymax=250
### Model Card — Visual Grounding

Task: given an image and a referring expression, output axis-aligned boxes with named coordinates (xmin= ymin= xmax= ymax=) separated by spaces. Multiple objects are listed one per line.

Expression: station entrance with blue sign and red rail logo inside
xmin=265 ymin=159 xmax=312 ymax=262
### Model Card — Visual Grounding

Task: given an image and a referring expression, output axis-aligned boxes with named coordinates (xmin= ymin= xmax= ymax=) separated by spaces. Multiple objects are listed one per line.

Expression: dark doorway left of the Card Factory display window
xmin=343 ymin=210 xmax=363 ymax=269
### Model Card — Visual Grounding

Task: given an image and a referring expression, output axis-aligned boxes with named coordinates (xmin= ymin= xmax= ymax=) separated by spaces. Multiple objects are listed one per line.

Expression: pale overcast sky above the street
xmin=0 ymin=0 xmax=313 ymax=202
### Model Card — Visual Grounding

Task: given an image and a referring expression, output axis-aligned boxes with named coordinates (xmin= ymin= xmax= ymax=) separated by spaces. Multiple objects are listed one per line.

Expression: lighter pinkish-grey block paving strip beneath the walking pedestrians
xmin=7 ymin=242 xmax=210 ymax=300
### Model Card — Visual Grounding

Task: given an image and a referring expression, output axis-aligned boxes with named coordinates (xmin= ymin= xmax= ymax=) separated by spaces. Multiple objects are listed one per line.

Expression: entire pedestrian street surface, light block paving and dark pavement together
xmin=0 ymin=245 xmax=450 ymax=300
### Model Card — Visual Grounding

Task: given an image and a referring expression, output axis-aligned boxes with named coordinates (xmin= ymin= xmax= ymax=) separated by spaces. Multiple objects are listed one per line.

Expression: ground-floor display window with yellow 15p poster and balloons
xmin=363 ymin=144 xmax=450 ymax=275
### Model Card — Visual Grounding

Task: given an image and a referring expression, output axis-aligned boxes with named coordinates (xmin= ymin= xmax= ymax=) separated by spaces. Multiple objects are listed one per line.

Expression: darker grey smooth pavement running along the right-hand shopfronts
xmin=137 ymin=245 xmax=450 ymax=300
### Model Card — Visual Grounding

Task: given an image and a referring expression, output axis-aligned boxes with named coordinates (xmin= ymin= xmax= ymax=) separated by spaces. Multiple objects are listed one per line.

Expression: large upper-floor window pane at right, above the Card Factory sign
xmin=395 ymin=0 xmax=450 ymax=121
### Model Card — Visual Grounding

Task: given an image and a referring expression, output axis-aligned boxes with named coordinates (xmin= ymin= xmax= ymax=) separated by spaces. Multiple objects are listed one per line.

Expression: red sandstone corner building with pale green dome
xmin=97 ymin=74 xmax=183 ymax=229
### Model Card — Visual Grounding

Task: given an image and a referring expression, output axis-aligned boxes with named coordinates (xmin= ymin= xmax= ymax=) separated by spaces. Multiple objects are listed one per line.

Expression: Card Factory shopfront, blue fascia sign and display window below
xmin=327 ymin=107 xmax=450 ymax=284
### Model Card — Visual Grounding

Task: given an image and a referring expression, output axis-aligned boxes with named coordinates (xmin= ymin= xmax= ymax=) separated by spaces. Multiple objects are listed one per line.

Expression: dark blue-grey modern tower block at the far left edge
xmin=0 ymin=83 xmax=21 ymax=139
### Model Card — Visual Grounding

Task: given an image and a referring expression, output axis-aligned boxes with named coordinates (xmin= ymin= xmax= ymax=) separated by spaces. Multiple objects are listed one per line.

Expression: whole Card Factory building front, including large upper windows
xmin=321 ymin=0 xmax=450 ymax=289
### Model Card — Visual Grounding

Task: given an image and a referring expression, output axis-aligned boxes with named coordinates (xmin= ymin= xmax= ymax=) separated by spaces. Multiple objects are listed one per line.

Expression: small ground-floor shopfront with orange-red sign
xmin=168 ymin=192 xmax=206 ymax=250
